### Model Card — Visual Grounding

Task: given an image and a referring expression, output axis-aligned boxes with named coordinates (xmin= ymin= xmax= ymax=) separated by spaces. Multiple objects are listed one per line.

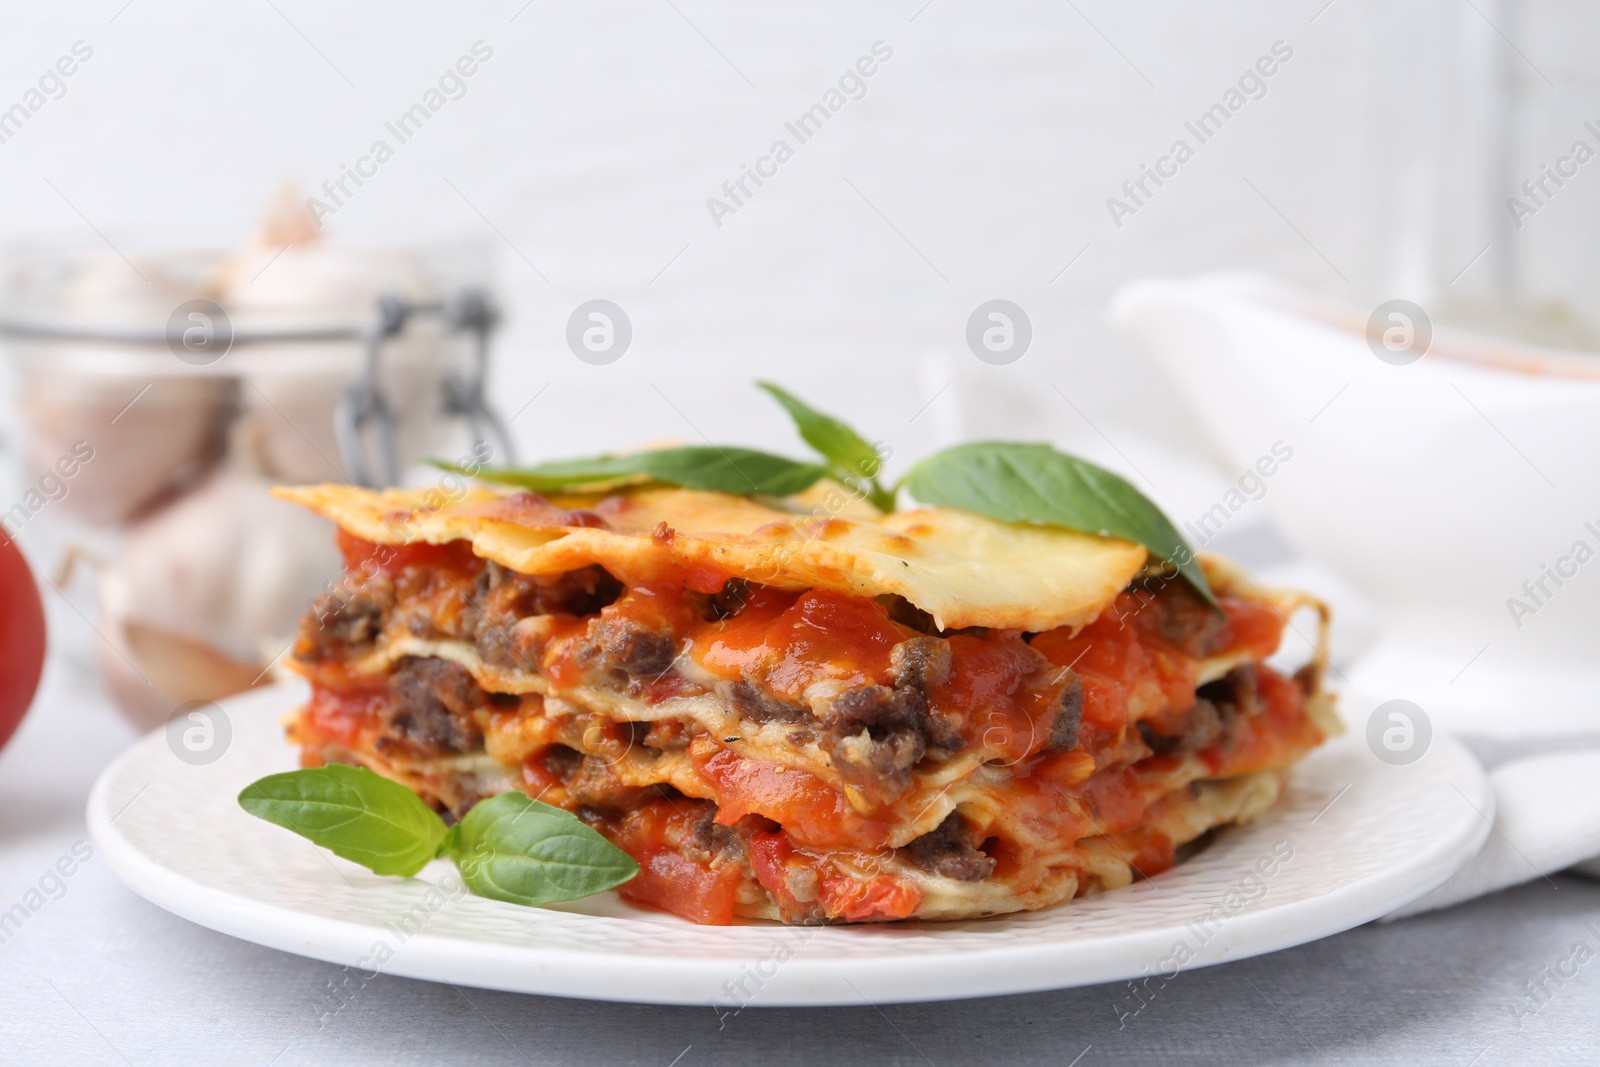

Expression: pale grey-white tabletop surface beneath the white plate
xmin=0 ymin=600 xmax=1600 ymax=1067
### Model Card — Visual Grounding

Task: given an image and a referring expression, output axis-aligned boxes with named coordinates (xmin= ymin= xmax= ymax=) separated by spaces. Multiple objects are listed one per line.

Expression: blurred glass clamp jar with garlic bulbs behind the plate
xmin=0 ymin=240 xmax=512 ymax=726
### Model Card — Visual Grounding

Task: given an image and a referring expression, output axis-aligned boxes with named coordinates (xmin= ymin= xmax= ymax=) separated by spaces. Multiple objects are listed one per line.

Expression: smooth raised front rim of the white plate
xmin=86 ymin=685 xmax=1494 ymax=1011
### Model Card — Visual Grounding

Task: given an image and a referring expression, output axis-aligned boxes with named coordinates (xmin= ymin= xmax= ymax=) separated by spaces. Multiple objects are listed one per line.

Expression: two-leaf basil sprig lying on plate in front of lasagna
xmin=238 ymin=763 xmax=638 ymax=907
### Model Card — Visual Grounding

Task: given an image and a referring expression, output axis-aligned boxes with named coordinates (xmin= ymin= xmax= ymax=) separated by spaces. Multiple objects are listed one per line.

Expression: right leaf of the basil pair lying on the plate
xmin=451 ymin=792 xmax=638 ymax=907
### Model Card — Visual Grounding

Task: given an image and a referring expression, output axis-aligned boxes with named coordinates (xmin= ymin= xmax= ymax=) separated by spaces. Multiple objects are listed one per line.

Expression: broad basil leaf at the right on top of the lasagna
xmin=904 ymin=442 xmax=1218 ymax=608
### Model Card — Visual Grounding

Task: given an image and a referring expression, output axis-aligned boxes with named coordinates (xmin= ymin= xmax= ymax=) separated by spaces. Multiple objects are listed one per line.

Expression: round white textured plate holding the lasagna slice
xmin=88 ymin=686 xmax=1494 ymax=1011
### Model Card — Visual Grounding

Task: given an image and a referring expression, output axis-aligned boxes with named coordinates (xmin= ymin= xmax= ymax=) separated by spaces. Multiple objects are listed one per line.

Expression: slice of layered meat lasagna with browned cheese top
xmin=280 ymin=486 xmax=1336 ymax=923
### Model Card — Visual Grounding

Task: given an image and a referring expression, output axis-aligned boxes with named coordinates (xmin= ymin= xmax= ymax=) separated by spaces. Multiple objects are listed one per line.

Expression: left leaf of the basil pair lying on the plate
xmin=238 ymin=763 xmax=445 ymax=875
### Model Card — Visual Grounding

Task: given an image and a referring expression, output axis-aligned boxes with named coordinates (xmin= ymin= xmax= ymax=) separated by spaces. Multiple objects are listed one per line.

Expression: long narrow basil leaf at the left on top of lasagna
xmin=440 ymin=445 xmax=827 ymax=496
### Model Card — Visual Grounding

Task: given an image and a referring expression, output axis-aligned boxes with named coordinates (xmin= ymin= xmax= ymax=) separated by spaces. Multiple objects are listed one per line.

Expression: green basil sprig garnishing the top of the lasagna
xmin=442 ymin=382 xmax=1218 ymax=608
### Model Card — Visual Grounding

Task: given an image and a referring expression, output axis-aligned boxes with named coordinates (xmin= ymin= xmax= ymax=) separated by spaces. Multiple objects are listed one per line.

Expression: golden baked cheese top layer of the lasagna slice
xmin=275 ymin=485 xmax=1146 ymax=630
